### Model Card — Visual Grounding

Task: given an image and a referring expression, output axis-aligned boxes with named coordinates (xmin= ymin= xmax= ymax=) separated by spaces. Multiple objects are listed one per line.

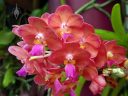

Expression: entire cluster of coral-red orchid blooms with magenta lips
xmin=9 ymin=5 xmax=128 ymax=96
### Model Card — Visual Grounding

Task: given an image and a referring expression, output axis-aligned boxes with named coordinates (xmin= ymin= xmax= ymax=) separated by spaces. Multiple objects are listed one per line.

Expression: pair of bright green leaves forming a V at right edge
xmin=96 ymin=4 xmax=128 ymax=48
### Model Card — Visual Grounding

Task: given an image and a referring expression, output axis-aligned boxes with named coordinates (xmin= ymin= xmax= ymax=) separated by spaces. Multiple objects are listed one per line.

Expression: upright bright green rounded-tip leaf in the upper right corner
xmin=111 ymin=4 xmax=125 ymax=37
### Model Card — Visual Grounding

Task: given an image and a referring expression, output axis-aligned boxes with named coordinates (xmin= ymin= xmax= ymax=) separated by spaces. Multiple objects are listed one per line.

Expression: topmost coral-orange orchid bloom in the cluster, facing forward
xmin=48 ymin=5 xmax=84 ymax=42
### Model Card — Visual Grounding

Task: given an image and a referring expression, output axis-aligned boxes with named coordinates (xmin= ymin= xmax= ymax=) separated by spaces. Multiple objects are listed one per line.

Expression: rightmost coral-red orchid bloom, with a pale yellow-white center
xmin=105 ymin=41 xmax=126 ymax=66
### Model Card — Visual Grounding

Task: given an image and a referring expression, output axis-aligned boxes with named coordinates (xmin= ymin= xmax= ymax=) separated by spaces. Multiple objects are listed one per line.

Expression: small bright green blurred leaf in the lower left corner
xmin=3 ymin=68 xmax=14 ymax=87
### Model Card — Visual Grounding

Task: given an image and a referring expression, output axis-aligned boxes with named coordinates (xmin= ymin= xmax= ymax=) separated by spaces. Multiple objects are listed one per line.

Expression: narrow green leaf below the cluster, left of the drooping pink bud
xmin=75 ymin=76 xmax=86 ymax=96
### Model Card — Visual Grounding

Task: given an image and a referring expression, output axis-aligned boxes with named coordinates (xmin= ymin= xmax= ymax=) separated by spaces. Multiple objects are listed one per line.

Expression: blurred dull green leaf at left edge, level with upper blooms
xmin=0 ymin=32 xmax=15 ymax=46
